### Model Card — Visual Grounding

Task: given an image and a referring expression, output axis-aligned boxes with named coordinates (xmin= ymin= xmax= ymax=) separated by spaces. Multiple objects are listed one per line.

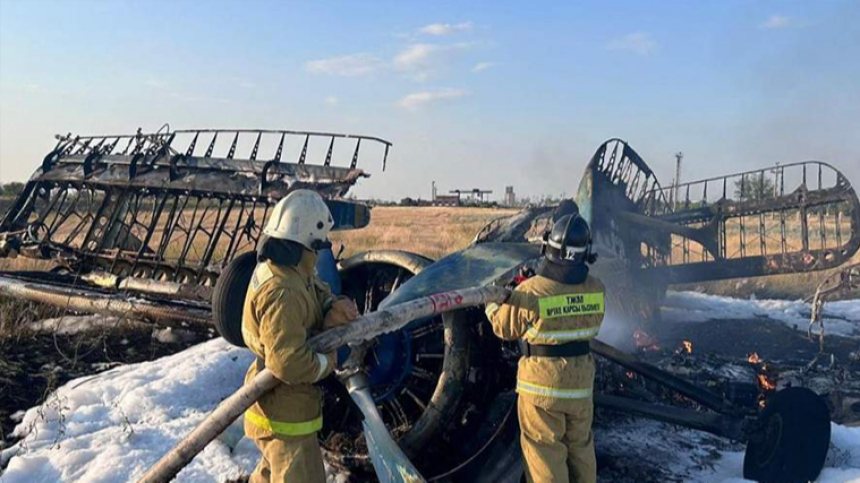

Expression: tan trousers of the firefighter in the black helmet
xmin=517 ymin=397 xmax=597 ymax=483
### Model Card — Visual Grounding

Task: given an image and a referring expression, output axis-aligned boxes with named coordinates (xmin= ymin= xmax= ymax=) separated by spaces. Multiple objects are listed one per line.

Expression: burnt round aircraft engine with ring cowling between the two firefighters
xmin=320 ymin=250 xmax=523 ymax=483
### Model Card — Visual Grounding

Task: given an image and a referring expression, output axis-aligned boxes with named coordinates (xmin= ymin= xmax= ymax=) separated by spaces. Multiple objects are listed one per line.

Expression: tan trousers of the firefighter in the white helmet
xmin=248 ymin=433 xmax=326 ymax=483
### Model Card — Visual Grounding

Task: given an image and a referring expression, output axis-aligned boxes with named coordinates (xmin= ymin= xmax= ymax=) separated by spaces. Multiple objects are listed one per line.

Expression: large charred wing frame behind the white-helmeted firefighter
xmin=0 ymin=129 xmax=391 ymax=288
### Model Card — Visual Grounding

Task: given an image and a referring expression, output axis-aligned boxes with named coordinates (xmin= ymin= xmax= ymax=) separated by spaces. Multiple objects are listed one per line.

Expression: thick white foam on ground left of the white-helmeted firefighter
xmin=2 ymin=339 xmax=259 ymax=483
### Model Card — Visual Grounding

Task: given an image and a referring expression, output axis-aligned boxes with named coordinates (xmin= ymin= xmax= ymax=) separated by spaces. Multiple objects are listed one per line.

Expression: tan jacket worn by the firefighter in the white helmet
xmin=242 ymin=251 xmax=336 ymax=439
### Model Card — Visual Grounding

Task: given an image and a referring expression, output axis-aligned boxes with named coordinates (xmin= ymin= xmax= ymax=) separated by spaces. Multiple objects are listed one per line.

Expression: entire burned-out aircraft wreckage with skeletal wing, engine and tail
xmin=0 ymin=130 xmax=860 ymax=482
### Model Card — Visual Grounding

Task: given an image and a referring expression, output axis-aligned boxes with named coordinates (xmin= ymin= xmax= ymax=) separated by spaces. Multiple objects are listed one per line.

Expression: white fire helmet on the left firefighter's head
xmin=263 ymin=190 xmax=334 ymax=250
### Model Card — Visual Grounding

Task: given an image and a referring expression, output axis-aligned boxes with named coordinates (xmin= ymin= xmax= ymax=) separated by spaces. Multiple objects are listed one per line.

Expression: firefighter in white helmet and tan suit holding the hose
xmin=242 ymin=190 xmax=358 ymax=483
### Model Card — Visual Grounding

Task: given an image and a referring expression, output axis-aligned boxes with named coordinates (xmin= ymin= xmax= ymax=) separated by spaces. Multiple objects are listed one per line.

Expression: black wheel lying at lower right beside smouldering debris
xmin=744 ymin=387 xmax=830 ymax=483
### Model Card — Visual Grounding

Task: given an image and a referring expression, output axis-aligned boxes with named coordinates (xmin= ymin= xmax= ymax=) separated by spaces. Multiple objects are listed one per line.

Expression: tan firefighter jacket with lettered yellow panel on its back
xmin=487 ymin=275 xmax=605 ymax=410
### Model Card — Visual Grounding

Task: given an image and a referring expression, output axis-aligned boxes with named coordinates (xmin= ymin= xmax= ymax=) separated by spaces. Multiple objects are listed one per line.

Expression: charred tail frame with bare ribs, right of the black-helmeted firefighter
xmin=578 ymin=139 xmax=860 ymax=283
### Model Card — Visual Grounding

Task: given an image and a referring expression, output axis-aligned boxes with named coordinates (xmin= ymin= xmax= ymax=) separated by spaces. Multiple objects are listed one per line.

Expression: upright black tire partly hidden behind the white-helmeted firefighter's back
xmin=212 ymin=252 xmax=257 ymax=347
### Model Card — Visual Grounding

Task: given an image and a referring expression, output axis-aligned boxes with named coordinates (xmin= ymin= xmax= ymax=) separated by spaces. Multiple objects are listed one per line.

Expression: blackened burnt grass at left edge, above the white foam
xmin=0 ymin=323 xmax=214 ymax=448
